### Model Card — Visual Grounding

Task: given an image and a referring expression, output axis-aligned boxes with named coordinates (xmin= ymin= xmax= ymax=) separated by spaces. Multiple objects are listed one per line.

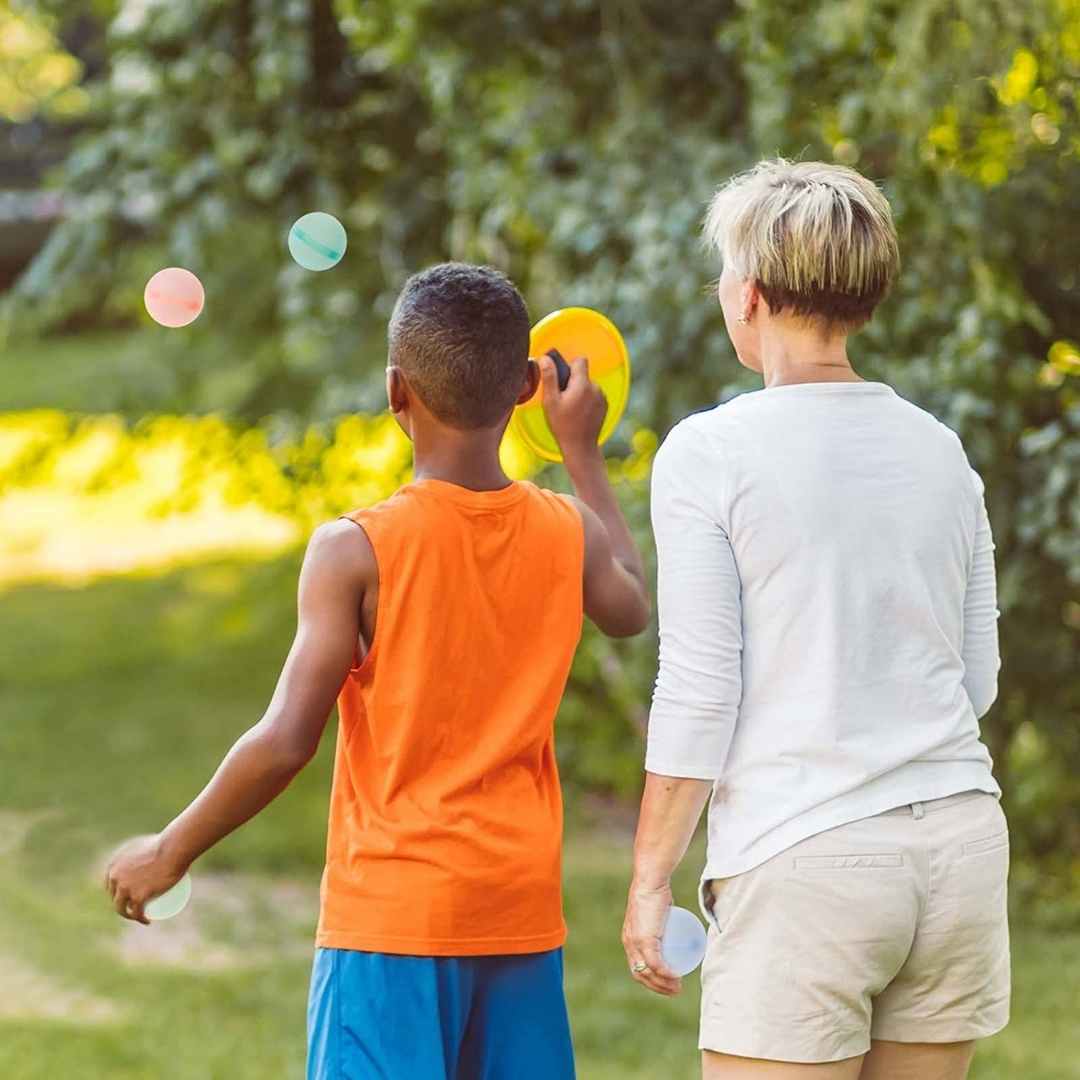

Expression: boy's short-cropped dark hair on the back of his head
xmin=389 ymin=262 xmax=529 ymax=429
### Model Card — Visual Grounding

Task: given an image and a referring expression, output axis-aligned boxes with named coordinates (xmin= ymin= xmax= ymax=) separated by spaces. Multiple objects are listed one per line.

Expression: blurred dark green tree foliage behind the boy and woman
xmin=8 ymin=0 xmax=1080 ymax=912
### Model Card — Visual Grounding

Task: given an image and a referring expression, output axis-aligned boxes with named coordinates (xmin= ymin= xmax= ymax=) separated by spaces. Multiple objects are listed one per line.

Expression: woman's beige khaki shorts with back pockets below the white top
xmin=698 ymin=792 xmax=1010 ymax=1062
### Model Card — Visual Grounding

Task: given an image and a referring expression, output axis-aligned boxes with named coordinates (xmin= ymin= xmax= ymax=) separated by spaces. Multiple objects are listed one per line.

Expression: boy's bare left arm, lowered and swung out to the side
xmin=105 ymin=519 xmax=377 ymax=923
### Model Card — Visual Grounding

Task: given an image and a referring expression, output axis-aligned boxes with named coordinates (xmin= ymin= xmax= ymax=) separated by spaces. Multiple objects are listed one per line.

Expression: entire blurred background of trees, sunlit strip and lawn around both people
xmin=0 ymin=0 xmax=1080 ymax=1080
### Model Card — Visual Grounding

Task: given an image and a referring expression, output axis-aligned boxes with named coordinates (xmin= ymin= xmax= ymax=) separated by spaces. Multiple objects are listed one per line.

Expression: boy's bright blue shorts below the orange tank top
xmin=307 ymin=948 xmax=575 ymax=1080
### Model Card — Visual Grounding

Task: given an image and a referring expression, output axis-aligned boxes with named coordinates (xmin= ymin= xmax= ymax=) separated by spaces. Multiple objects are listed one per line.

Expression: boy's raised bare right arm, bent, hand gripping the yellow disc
xmin=539 ymin=356 xmax=649 ymax=637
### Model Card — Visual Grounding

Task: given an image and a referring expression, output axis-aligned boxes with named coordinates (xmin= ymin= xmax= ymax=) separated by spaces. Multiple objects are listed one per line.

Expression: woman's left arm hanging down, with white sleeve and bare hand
xmin=623 ymin=421 xmax=742 ymax=994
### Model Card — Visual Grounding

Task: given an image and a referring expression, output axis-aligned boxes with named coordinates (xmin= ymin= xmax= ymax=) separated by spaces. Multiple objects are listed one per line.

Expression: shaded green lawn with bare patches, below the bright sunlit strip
xmin=0 ymin=556 xmax=1080 ymax=1080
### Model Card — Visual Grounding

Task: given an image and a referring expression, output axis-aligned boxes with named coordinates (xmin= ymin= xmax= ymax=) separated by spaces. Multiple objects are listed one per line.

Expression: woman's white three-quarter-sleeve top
xmin=645 ymin=380 xmax=1000 ymax=877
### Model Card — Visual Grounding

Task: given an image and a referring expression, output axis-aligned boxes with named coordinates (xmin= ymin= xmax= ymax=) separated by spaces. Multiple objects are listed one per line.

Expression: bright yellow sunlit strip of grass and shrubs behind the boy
xmin=0 ymin=409 xmax=552 ymax=585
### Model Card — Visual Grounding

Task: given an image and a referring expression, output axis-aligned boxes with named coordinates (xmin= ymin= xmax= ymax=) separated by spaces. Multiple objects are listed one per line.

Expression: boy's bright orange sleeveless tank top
xmin=315 ymin=480 xmax=584 ymax=956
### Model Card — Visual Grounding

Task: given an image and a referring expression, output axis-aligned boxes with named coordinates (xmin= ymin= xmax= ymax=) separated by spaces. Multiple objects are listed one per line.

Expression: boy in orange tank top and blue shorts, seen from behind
xmin=106 ymin=262 xmax=649 ymax=1080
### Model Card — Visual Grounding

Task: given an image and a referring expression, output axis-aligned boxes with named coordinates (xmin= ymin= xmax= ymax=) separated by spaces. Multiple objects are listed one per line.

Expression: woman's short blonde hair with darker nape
xmin=703 ymin=158 xmax=900 ymax=332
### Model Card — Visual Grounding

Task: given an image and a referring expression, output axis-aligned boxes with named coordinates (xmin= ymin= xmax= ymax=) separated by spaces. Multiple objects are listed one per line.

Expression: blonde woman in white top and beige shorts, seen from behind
xmin=622 ymin=159 xmax=1010 ymax=1080
